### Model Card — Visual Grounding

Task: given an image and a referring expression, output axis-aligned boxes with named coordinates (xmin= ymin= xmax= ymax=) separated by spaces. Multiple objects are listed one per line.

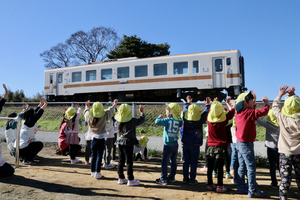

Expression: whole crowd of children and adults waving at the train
xmin=0 ymin=84 xmax=300 ymax=199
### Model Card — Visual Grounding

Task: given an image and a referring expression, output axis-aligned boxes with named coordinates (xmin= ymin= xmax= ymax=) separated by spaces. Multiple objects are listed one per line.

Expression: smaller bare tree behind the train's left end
xmin=40 ymin=43 xmax=74 ymax=69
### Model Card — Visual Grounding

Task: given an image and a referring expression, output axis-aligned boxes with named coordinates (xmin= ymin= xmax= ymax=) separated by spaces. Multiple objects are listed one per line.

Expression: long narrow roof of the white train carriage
xmin=45 ymin=49 xmax=239 ymax=72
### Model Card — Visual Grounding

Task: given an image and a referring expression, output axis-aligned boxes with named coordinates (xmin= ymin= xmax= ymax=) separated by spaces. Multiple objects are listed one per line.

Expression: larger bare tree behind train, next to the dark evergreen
xmin=66 ymin=27 xmax=119 ymax=62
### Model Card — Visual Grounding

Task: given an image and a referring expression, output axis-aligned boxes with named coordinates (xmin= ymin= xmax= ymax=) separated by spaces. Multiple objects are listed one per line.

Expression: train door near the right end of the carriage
xmin=213 ymin=58 xmax=226 ymax=88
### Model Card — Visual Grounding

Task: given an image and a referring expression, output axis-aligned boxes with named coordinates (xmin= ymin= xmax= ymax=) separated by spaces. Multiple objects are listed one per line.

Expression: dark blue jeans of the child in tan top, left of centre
xmin=91 ymin=138 xmax=105 ymax=172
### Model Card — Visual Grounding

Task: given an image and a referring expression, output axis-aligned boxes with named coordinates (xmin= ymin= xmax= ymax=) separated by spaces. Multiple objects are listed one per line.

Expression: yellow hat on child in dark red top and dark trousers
xmin=207 ymin=101 xmax=226 ymax=123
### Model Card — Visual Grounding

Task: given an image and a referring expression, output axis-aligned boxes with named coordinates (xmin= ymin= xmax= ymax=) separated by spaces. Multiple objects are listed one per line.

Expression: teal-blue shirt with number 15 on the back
xmin=155 ymin=117 xmax=182 ymax=145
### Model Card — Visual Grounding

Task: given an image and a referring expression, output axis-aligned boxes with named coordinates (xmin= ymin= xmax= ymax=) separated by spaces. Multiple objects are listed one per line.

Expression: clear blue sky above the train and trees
xmin=0 ymin=0 xmax=300 ymax=100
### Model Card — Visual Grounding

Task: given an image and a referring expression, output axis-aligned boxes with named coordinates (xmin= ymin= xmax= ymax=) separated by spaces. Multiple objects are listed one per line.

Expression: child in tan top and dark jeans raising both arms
xmin=84 ymin=99 xmax=118 ymax=179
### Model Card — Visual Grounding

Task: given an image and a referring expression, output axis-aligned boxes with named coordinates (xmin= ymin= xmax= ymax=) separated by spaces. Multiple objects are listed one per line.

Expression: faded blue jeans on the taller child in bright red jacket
xmin=236 ymin=141 xmax=257 ymax=192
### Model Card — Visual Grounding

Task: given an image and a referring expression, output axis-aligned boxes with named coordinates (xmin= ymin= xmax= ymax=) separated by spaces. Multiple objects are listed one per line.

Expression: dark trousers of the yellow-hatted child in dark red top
xmin=206 ymin=156 xmax=224 ymax=186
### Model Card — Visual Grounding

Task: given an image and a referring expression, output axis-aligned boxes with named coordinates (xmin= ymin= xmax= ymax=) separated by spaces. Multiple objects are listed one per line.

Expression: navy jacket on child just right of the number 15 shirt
xmin=181 ymin=103 xmax=210 ymax=146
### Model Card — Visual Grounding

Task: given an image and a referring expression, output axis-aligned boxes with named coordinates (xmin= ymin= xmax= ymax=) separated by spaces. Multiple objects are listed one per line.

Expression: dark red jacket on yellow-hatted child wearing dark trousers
xmin=207 ymin=109 xmax=235 ymax=148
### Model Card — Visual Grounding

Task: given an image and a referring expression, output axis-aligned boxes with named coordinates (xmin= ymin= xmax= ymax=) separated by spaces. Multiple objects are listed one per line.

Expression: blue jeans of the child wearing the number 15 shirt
xmin=160 ymin=142 xmax=178 ymax=180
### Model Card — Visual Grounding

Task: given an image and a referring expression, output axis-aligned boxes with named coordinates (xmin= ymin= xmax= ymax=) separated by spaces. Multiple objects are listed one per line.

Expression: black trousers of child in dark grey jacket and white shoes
xmin=118 ymin=145 xmax=134 ymax=180
